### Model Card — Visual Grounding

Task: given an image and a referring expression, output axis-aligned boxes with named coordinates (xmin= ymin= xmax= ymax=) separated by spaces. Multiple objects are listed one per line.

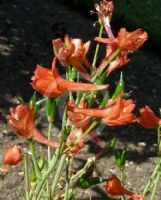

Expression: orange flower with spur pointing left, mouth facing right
xmin=74 ymin=93 xmax=136 ymax=126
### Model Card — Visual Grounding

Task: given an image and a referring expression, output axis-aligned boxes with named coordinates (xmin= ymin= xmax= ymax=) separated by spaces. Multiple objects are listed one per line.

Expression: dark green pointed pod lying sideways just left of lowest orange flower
xmin=76 ymin=177 xmax=107 ymax=189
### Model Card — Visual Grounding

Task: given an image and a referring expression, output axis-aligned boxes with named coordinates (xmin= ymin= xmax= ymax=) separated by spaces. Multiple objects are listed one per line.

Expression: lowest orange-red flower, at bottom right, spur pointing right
xmin=103 ymin=175 xmax=144 ymax=199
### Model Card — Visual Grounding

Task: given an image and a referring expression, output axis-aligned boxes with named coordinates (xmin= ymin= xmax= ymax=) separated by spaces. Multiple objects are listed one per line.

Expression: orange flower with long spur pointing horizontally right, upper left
xmin=32 ymin=58 xmax=108 ymax=98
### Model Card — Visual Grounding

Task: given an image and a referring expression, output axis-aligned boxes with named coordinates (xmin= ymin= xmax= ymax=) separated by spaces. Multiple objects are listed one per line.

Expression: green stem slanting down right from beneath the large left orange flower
xmin=29 ymin=140 xmax=41 ymax=179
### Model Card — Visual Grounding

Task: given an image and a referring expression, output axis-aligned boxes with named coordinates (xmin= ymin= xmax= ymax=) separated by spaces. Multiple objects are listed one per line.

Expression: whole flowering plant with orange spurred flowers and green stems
xmin=0 ymin=0 xmax=161 ymax=200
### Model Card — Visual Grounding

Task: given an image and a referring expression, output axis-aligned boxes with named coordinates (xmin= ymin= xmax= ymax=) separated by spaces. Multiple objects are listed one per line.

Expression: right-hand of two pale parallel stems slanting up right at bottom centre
xmin=51 ymin=154 xmax=66 ymax=196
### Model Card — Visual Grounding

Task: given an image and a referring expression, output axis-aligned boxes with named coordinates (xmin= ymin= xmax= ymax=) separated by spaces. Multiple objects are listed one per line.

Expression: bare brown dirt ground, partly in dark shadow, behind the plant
xmin=0 ymin=0 xmax=161 ymax=200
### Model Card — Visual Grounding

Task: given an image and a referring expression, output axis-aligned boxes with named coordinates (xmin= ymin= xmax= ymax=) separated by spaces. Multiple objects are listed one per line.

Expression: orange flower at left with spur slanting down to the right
xmin=6 ymin=105 xmax=59 ymax=147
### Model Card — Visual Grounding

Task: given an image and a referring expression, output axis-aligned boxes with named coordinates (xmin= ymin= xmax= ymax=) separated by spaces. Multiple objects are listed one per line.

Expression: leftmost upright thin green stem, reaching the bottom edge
xmin=24 ymin=152 xmax=29 ymax=200
